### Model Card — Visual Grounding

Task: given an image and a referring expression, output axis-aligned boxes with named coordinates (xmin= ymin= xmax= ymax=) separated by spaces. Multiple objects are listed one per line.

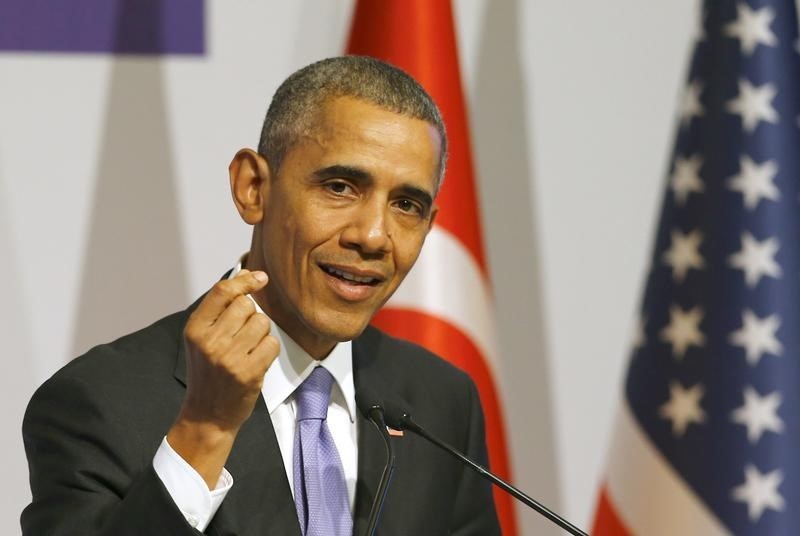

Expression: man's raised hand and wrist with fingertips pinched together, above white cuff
xmin=167 ymin=270 xmax=280 ymax=489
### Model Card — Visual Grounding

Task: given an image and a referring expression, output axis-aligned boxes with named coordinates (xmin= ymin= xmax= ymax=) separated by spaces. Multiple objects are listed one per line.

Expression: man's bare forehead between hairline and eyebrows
xmin=290 ymin=97 xmax=441 ymax=190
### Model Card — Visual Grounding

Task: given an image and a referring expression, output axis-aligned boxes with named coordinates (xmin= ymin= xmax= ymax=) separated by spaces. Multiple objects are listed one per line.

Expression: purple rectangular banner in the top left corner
xmin=0 ymin=0 xmax=205 ymax=54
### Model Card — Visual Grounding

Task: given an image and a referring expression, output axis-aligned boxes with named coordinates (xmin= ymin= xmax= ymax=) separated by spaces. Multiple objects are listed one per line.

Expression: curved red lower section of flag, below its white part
xmin=372 ymin=307 xmax=517 ymax=536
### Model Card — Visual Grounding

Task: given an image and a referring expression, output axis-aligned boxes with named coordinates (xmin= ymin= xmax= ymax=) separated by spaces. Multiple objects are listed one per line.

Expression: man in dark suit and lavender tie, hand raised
xmin=22 ymin=56 xmax=499 ymax=536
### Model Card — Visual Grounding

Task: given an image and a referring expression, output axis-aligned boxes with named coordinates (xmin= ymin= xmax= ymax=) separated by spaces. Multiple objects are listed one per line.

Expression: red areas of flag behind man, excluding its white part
xmin=347 ymin=0 xmax=517 ymax=536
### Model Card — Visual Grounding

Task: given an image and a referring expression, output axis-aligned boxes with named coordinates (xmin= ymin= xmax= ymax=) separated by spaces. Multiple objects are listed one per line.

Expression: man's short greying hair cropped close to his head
xmin=258 ymin=56 xmax=447 ymax=190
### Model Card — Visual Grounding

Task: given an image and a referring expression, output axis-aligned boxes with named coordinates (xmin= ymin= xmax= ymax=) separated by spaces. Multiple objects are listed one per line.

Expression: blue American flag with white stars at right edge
xmin=594 ymin=0 xmax=800 ymax=535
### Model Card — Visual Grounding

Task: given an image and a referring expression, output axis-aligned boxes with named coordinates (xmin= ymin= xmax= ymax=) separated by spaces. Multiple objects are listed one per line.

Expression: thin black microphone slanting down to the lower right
xmin=383 ymin=401 xmax=589 ymax=536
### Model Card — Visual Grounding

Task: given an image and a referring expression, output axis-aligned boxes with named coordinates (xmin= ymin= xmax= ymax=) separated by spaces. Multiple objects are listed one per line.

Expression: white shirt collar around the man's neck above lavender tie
xmin=228 ymin=255 xmax=356 ymax=422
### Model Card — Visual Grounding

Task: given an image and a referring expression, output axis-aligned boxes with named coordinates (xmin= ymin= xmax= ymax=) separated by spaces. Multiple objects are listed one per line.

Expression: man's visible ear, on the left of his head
xmin=228 ymin=149 xmax=270 ymax=225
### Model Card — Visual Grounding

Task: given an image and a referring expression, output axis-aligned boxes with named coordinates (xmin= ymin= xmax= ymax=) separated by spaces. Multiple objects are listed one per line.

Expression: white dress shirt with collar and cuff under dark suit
xmin=153 ymin=261 xmax=358 ymax=532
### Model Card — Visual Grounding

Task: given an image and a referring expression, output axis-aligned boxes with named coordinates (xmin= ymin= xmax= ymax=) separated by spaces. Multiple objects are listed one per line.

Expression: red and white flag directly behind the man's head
xmin=347 ymin=0 xmax=517 ymax=536
